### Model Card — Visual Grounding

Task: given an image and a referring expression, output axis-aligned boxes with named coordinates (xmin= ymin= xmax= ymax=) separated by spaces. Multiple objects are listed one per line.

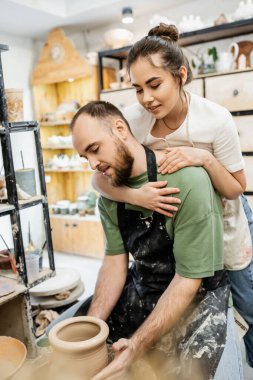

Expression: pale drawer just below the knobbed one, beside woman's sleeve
xmin=234 ymin=115 xmax=253 ymax=152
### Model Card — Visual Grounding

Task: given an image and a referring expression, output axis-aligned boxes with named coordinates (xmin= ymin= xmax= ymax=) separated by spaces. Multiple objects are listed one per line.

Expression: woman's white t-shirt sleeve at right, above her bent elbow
xmin=213 ymin=112 xmax=244 ymax=173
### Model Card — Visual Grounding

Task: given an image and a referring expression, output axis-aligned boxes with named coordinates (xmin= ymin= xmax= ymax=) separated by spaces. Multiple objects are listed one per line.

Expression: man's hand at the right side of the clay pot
xmin=91 ymin=338 xmax=136 ymax=380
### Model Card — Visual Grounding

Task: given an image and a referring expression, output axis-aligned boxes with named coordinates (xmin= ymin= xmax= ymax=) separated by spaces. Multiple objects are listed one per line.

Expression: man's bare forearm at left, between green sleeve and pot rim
xmin=87 ymin=254 xmax=128 ymax=320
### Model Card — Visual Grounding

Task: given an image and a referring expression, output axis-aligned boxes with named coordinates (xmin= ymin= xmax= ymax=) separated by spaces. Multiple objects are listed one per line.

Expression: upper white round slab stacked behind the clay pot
xmin=30 ymin=268 xmax=81 ymax=297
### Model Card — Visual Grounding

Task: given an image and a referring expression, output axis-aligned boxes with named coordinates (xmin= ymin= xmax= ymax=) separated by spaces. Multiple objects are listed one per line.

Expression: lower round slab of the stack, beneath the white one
xmin=31 ymin=280 xmax=84 ymax=309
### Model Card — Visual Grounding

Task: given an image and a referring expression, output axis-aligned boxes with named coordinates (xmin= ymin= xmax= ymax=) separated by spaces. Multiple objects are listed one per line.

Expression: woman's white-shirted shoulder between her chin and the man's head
xmin=123 ymin=103 xmax=155 ymax=143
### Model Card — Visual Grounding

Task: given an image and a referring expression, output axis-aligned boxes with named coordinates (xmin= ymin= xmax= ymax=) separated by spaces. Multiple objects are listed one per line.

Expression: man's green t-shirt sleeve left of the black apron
xmin=98 ymin=197 xmax=126 ymax=256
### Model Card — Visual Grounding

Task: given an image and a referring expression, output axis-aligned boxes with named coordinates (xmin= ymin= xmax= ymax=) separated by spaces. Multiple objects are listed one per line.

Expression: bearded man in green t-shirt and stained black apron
xmin=50 ymin=101 xmax=242 ymax=380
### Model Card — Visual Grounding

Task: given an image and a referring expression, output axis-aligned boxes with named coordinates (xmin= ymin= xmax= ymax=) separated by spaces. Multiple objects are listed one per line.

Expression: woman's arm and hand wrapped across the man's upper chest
xmin=92 ymin=172 xmax=181 ymax=217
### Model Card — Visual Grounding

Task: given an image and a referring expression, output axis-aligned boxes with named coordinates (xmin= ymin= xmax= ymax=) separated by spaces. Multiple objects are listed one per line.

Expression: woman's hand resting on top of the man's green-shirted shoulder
xmin=158 ymin=146 xmax=211 ymax=174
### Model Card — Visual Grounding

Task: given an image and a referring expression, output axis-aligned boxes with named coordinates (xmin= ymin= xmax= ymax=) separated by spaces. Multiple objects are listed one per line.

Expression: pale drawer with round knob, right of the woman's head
xmin=205 ymin=71 xmax=253 ymax=111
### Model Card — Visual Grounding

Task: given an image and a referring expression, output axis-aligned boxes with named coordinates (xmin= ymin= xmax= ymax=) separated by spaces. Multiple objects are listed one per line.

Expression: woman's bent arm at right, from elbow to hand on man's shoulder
xmin=158 ymin=146 xmax=246 ymax=199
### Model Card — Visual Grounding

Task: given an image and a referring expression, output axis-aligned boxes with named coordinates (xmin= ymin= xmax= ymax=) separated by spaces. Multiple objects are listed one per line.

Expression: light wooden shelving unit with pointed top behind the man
xmin=32 ymin=29 xmax=107 ymax=257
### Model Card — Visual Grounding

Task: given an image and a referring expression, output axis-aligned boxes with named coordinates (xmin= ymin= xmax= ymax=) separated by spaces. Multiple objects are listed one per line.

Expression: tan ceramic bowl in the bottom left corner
xmin=0 ymin=336 xmax=27 ymax=380
